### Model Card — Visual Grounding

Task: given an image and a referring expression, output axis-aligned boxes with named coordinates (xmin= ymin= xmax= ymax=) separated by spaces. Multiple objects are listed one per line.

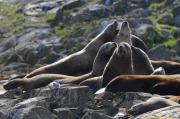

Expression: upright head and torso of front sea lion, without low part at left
xmin=102 ymin=42 xmax=134 ymax=87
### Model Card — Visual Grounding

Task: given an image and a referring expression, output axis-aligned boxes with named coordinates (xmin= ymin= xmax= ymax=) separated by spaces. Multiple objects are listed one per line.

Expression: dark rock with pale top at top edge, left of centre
xmin=63 ymin=0 xmax=85 ymax=10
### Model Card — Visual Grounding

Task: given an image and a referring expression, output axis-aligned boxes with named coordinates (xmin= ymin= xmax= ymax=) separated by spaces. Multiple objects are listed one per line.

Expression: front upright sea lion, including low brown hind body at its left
xmin=80 ymin=42 xmax=133 ymax=91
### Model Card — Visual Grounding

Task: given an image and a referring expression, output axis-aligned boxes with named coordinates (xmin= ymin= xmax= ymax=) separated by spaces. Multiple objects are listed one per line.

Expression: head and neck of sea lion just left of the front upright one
xmin=92 ymin=42 xmax=117 ymax=76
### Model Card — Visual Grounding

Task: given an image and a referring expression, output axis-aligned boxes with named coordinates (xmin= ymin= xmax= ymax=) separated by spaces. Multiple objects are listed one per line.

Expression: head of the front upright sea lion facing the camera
xmin=115 ymin=42 xmax=132 ymax=60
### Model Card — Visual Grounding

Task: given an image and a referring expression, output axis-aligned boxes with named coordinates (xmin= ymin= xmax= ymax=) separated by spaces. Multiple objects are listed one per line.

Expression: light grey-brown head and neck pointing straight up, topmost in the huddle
xmin=115 ymin=21 xmax=132 ymax=45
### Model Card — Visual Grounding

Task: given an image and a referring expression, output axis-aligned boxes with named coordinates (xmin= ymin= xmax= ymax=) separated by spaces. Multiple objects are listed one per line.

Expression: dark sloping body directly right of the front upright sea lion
xmin=131 ymin=46 xmax=154 ymax=74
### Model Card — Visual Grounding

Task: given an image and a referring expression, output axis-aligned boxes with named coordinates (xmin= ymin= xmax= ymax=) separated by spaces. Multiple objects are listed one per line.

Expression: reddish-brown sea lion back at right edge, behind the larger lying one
xmin=151 ymin=60 xmax=180 ymax=75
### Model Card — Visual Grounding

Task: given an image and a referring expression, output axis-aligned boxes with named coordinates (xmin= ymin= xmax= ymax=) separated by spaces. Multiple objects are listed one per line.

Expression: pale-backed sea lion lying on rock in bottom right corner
xmin=128 ymin=97 xmax=179 ymax=116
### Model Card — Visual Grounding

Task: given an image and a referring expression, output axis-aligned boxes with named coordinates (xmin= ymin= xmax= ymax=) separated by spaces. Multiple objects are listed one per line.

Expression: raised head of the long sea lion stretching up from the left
xmin=104 ymin=21 xmax=119 ymax=37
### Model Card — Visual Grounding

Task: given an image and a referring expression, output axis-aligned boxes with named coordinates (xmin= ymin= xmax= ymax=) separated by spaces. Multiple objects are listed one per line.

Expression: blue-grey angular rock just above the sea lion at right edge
xmin=148 ymin=44 xmax=177 ymax=60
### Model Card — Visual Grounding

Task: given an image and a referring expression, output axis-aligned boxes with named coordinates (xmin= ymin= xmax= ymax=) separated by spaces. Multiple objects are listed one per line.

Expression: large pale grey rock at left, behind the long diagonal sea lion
xmin=0 ymin=28 xmax=62 ymax=65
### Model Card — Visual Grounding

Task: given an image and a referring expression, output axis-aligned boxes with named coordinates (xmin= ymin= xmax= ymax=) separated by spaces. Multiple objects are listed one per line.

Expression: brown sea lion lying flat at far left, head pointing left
xmin=3 ymin=74 xmax=75 ymax=91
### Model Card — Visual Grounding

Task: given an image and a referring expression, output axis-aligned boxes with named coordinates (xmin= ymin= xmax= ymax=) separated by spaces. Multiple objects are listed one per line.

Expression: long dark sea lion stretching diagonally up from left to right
xmin=26 ymin=21 xmax=118 ymax=78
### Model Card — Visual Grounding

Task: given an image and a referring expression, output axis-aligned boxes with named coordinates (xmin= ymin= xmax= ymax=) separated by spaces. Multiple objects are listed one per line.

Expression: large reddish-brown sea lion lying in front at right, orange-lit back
xmin=106 ymin=75 xmax=180 ymax=95
